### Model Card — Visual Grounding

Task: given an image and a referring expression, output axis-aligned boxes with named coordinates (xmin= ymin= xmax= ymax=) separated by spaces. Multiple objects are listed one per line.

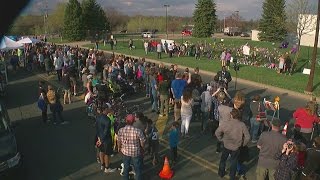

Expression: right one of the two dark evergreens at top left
xmin=81 ymin=0 xmax=110 ymax=36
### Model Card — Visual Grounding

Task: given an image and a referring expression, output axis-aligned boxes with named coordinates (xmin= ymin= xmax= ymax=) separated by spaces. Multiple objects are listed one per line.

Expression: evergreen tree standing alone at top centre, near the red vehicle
xmin=192 ymin=0 xmax=217 ymax=37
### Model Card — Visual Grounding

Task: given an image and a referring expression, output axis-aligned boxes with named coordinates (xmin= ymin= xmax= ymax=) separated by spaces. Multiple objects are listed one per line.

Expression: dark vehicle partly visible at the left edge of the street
xmin=0 ymin=100 xmax=21 ymax=175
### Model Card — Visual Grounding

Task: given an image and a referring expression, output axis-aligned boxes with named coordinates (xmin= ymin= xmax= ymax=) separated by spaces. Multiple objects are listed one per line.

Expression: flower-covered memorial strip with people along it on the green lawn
xmin=143 ymin=39 xmax=297 ymax=75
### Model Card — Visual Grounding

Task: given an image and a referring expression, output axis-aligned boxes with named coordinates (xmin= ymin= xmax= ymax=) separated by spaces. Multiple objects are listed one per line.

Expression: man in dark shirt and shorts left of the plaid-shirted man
xmin=96 ymin=106 xmax=115 ymax=173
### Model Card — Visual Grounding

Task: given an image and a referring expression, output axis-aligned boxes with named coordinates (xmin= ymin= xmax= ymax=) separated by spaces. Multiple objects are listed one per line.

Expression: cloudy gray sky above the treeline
xmin=24 ymin=0 xmax=316 ymax=20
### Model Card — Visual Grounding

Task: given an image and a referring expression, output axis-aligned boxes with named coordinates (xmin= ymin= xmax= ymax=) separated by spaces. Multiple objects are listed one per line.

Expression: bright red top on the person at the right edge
xmin=293 ymin=108 xmax=319 ymax=129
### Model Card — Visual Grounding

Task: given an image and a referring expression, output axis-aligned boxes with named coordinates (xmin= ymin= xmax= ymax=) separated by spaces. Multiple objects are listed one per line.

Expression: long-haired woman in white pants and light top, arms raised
xmin=181 ymin=88 xmax=193 ymax=137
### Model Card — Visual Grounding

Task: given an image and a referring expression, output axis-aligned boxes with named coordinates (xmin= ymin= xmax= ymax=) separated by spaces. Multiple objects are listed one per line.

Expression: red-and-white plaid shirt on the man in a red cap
xmin=117 ymin=125 xmax=146 ymax=157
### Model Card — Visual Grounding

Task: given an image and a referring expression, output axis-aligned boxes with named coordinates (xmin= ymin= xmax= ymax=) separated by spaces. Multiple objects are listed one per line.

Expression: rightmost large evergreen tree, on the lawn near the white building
xmin=259 ymin=0 xmax=287 ymax=42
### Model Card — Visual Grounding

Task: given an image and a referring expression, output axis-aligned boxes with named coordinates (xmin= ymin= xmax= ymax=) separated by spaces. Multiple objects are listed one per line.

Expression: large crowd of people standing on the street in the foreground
xmin=3 ymin=39 xmax=320 ymax=180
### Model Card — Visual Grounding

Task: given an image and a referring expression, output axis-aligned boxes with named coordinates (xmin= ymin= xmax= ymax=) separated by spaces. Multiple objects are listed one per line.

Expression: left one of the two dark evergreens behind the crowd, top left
xmin=63 ymin=0 xmax=85 ymax=41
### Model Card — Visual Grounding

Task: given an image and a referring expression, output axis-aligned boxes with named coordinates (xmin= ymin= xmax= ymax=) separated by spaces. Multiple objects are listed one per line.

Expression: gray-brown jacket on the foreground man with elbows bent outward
xmin=215 ymin=118 xmax=250 ymax=151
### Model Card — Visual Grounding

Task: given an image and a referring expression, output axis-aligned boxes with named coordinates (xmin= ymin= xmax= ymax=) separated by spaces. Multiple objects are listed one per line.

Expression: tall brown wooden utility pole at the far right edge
xmin=304 ymin=0 xmax=320 ymax=94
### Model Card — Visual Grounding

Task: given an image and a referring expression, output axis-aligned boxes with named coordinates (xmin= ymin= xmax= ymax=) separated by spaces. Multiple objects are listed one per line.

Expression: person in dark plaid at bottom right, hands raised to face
xmin=274 ymin=140 xmax=298 ymax=180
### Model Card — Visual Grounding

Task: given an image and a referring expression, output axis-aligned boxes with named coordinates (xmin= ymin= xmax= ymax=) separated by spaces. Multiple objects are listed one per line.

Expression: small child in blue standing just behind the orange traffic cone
xmin=169 ymin=121 xmax=179 ymax=164
